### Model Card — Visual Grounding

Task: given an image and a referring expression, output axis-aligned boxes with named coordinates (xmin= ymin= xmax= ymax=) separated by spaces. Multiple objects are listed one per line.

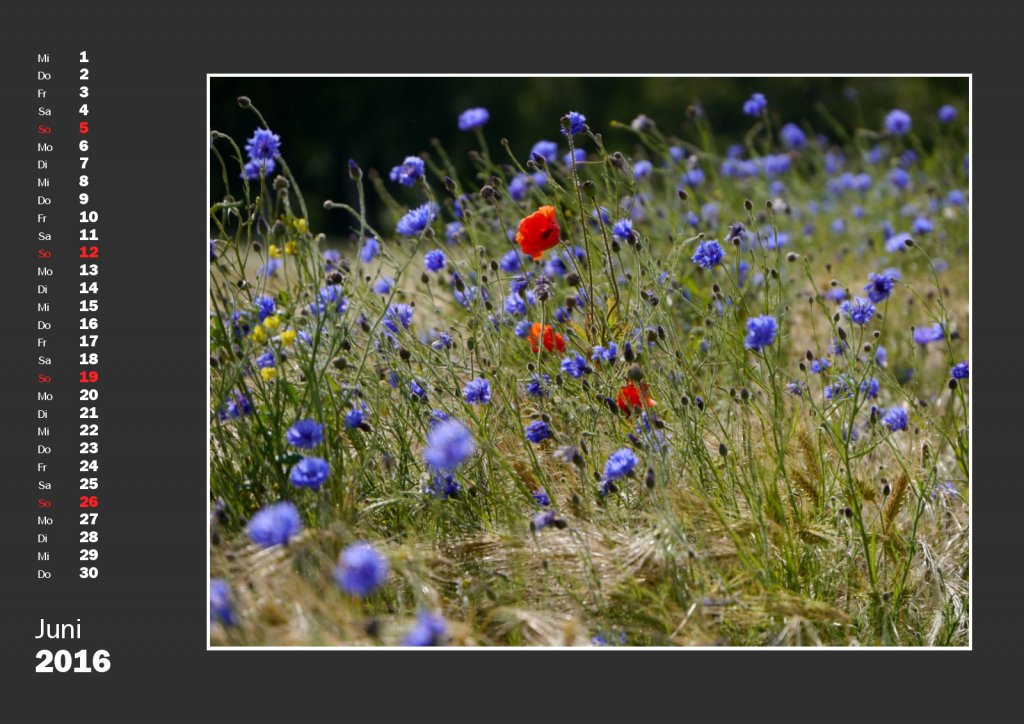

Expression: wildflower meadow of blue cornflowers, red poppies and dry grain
xmin=209 ymin=79 xmax=971 ymax=647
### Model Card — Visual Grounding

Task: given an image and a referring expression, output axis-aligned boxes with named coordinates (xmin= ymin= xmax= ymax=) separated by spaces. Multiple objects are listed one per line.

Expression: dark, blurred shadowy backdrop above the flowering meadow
xmin=210 ymin=77 xmax=969 ymax=238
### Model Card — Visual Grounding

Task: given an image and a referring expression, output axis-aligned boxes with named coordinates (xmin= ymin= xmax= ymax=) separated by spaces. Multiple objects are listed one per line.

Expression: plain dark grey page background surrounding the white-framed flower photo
xmin=0 ymin=7 xmax=991 ymax=723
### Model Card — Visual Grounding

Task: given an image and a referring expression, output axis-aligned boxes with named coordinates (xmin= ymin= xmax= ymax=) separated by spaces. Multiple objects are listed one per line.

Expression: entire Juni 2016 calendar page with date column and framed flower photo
xmin=0 ymin=17 xmax=978 ymax=722
